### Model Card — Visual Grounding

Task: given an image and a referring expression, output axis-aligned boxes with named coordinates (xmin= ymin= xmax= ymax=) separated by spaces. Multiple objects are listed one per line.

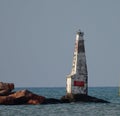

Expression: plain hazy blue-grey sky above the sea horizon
xmin=0 ymin=0 xmax=120 ymax=87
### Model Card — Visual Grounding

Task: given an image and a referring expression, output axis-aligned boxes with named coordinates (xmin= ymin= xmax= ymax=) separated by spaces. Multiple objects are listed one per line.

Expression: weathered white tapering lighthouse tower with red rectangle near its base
xmin=66 ymin=30 xmax=88 ymax=95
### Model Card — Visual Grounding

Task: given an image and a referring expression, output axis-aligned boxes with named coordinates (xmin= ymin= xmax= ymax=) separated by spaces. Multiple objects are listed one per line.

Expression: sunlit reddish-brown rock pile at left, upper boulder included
xmin=0 ymin=82 xmax=45 ymax=105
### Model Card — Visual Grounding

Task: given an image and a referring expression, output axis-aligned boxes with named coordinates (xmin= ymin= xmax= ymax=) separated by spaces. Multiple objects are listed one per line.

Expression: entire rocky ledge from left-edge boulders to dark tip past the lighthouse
xmin=0 ymin=82 xmax=109 ymax=105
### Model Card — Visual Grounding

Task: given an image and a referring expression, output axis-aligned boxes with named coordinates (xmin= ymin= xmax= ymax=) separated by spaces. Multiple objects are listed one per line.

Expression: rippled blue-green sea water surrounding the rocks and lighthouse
xmin=0 ymin=87 xmax=120 ymax=116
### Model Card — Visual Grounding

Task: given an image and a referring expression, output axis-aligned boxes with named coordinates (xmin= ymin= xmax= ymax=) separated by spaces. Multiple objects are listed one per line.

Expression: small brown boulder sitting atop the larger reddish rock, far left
xmin=0 ymin=82 xmax=14 ymax=96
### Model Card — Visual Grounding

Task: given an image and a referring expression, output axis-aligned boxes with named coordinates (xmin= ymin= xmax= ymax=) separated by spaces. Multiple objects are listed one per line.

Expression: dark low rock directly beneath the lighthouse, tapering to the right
xmin=61 ymin=94 xmax=110 ymax=103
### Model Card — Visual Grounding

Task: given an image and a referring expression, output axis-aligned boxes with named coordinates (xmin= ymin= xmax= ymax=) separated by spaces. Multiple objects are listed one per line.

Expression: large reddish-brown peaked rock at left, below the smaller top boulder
xmin=0 ymin=90 xmax=45 ymax=105
